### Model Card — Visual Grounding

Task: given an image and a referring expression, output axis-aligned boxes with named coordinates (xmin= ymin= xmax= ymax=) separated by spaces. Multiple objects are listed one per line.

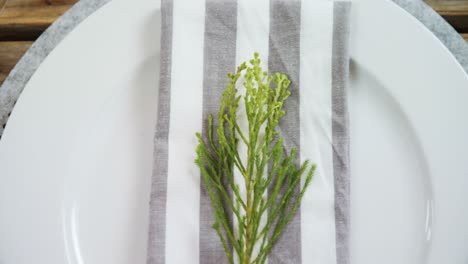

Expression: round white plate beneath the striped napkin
xmin=0 ymin=0 xmax=468 ymax=264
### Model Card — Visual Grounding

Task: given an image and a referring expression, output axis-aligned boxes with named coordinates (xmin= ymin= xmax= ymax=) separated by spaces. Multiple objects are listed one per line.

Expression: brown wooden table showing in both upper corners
xmin=0 ymin=0 xmax=468 ymax=84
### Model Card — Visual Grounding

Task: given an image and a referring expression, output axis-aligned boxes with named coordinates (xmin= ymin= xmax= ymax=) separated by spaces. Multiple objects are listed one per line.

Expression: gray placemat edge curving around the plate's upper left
xmin=0 ymin=0 xmax=110 ymax=138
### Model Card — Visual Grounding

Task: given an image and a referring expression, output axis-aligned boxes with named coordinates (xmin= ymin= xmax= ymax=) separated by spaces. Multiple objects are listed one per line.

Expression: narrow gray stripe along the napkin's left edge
xmin=147 ymin=0 xmax=173 ymax=264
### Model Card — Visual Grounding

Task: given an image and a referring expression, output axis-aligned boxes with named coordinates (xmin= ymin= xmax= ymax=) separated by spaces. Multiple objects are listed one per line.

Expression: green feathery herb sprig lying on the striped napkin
xmin=195 ymin=53 xmax=316 ymax=264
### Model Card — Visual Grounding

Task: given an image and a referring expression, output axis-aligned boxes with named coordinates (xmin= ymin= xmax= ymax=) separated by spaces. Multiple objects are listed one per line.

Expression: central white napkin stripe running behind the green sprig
xmin=234 ymin=0 xmax=270 ymax=263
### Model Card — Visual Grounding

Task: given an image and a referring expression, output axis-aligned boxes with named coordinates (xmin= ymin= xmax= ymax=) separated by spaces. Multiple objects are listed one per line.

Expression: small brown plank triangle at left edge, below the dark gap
xmin=0 ymin=41 xmax=32 ymax=85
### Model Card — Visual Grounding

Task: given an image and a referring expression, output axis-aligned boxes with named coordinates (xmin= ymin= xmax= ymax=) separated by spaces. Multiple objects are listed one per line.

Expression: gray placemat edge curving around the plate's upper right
xmin=392 ymin=0 xmax=468 ymax=73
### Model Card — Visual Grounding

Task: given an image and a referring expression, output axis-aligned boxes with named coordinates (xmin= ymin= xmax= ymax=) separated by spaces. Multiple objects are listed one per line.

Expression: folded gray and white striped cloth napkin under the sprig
xmin=148 ymin=0 xmax=350 ymax=264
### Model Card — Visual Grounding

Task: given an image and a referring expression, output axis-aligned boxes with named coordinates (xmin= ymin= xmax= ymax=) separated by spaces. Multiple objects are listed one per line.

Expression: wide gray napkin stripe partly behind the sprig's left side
xmin=199 ymin=0 xmax=237 ymax=264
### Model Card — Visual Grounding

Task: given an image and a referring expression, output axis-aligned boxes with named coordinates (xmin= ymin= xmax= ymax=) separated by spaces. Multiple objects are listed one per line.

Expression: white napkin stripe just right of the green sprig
xmin=300 ymin=1 xmax=336 ymax=264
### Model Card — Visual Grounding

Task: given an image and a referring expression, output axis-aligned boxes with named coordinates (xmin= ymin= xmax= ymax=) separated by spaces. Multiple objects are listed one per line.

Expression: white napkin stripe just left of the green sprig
xmin=166 ymin=0 xmax=205 ymax=264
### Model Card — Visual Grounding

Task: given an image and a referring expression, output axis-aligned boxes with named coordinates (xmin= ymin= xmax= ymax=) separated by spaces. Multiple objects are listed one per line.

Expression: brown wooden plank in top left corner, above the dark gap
xmin=0 ymin=0 xmax=77 ymax=41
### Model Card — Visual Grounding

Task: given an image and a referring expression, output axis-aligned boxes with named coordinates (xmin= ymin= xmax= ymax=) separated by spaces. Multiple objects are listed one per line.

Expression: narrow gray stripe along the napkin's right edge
xmin=332 ymin=2 xmax=351 ymax=264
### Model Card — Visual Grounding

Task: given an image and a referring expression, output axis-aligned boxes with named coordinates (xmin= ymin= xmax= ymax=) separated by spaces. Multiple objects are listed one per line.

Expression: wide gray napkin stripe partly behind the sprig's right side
xmin=268 ymin=0 xmax=302 ymax=264
